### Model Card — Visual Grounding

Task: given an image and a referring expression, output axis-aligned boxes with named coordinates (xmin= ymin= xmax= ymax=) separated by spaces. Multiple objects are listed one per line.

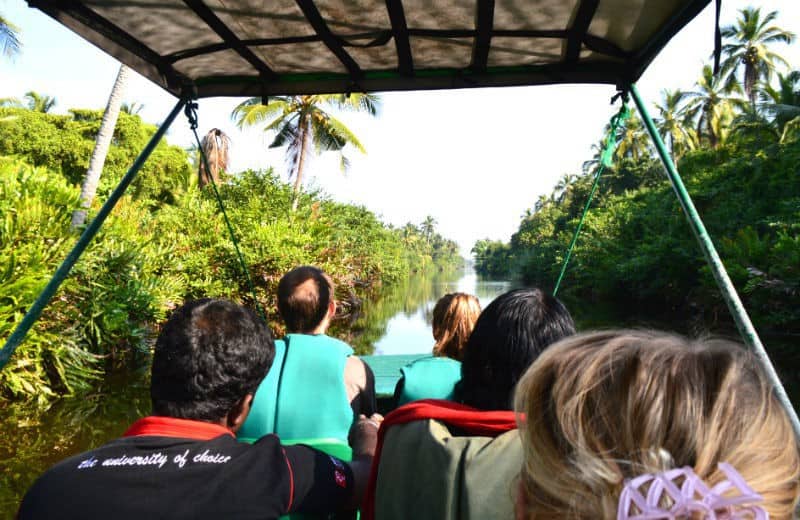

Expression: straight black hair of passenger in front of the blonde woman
xmin=456 ymin=288 xmax=575 ymax=410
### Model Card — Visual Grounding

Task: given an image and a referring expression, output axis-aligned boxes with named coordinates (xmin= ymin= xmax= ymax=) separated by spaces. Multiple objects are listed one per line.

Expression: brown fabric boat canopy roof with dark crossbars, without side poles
xmin=28 ymin=0 xmax=710 ymax=97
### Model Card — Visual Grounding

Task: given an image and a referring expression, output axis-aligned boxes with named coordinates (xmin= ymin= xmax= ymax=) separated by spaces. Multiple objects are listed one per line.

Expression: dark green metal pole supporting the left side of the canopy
xmin=0 ymin=98 xmax=187 ymax=369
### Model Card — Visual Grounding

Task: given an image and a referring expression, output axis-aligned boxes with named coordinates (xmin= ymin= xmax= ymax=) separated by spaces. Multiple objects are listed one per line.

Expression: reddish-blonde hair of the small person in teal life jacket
xmin=433 ymin=293 xmax=481 ymax=361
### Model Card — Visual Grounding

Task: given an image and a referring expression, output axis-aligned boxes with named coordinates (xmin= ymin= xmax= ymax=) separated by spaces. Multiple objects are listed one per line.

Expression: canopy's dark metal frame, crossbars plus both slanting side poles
xmin=0 ymin=0 xmax=800 ymax=438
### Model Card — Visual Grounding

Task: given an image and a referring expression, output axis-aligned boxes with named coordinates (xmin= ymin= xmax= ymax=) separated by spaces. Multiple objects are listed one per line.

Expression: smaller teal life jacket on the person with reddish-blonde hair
xmin=395 ymin=356 xmax=461 ymax=406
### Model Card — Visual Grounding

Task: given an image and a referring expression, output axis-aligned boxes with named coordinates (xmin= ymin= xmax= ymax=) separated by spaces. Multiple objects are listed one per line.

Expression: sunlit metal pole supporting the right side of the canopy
xmin=630 ymin=84 xmax=800 ymax=439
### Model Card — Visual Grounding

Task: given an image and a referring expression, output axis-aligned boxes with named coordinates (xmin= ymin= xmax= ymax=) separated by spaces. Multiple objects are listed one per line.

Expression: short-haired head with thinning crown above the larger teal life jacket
xmin=278 ymin=265 xmax=333 ymax=332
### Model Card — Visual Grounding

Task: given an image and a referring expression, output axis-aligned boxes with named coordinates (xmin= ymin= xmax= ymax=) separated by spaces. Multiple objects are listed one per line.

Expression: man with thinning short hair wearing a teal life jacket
xmin=238 ymin=266 xmax=377 ymax=446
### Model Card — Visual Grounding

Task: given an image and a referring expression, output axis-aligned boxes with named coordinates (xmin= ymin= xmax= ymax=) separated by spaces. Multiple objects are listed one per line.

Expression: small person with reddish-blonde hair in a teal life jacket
xmin=394 ymin=293 xmax=481 ymax=406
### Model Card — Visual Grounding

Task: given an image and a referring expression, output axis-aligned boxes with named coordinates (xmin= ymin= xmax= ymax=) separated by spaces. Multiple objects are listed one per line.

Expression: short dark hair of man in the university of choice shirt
xmin=150 ymin=299 xmax=275 ymax=421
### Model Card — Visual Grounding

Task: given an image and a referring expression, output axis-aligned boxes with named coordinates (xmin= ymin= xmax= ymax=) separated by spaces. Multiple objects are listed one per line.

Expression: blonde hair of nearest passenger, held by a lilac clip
xmin=515 ymin=331 xmax=800 ymax=520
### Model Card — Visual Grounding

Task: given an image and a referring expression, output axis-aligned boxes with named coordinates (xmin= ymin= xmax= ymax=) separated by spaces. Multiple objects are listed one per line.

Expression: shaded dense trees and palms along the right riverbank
xmin=472 ymin=9 xmax=800 ymax=332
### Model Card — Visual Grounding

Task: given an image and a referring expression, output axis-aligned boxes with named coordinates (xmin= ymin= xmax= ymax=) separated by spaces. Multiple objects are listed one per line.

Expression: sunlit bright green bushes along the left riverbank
xmin=0 ymin=104 xmax=460 ymax=404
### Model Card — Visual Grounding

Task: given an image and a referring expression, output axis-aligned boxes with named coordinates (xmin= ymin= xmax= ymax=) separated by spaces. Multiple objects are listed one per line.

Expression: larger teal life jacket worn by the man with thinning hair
xmin=237 ymin=334 xmax=353 ymax=443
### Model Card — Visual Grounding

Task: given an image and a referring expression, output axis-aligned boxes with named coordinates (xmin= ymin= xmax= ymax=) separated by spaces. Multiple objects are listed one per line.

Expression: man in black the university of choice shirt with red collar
xmin=17 ymin=299 xmax=381 ymax=520
